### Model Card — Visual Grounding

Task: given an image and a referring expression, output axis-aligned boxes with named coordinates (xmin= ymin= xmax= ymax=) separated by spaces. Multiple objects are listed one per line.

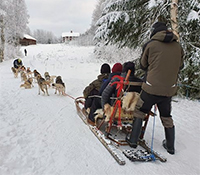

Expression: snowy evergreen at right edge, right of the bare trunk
xmin=178 ymin=0 xmax=200 ymax=98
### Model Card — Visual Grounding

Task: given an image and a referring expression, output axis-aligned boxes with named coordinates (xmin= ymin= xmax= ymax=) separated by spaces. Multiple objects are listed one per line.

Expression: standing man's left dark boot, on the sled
xmin=126 ymin=118 xmax=143 ymax=148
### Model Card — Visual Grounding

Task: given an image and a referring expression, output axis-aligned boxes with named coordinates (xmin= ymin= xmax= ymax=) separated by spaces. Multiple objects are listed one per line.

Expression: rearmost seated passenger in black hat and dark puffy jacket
xmin=101 ymin=62 xmax=142 ymax=107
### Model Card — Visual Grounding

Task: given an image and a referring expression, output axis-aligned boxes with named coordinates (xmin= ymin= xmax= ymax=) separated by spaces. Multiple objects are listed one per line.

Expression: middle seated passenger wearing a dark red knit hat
xmin=88 ymin=63 xmax=122 ymax=125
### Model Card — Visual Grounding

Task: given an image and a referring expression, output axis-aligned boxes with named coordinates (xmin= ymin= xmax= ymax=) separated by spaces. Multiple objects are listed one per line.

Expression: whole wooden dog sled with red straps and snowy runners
xmin=75 ymin=71 xmax=167 ymax=165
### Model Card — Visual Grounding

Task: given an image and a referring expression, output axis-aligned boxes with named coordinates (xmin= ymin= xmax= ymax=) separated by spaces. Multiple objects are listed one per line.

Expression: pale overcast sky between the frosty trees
xmin=25 ymin=0 xmax=98 ymax=37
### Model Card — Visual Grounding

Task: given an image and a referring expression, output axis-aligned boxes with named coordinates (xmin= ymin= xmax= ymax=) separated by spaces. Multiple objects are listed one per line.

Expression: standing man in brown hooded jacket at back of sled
xmin=126 ymin=22 xmax=184 ymax=154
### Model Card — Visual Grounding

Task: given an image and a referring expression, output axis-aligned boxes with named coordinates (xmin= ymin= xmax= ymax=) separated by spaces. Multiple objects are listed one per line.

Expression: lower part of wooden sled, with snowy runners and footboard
xmin=75 ymin=97 xmax=167 ymax=165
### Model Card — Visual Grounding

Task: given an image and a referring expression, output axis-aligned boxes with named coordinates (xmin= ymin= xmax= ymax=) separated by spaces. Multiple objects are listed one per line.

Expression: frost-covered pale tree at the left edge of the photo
xmin=0 ymin=0 xmax=28 ymax=59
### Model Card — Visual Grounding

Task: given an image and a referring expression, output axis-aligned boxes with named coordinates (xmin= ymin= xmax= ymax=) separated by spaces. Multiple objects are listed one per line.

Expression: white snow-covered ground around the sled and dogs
xmin=0 ymin=44 xmax=200 ymax=175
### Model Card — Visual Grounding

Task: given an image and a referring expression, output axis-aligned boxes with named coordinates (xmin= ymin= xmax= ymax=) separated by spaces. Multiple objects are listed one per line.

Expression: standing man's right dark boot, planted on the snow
xmin=162 ymin=126 xmax=175 ymax=154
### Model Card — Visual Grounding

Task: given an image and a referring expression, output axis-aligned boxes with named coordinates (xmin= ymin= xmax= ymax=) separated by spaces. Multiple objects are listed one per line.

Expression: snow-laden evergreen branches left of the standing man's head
xmin=95 ymin=0 xmax=169 ymax=48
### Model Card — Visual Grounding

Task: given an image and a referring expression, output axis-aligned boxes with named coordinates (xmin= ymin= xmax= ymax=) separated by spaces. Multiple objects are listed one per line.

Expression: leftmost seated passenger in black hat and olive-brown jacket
xmin=83 ymin=63 xmax=110 ymax=109
